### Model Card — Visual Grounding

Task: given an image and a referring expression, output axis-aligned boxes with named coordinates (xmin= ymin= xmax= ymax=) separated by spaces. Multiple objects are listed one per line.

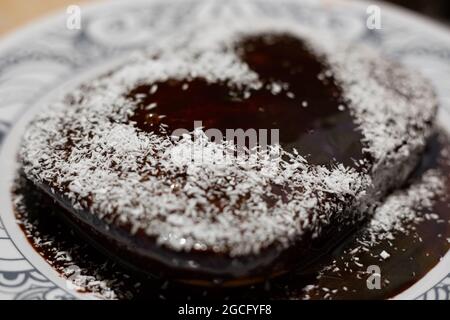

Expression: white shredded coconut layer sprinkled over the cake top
xmin=20 ymin=22 xmax=436 ymax=256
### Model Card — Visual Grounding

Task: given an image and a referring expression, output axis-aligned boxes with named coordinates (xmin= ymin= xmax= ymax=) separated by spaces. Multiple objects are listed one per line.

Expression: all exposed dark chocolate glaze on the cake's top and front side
xmin=18 ymin=35 xmax=426 ymax=286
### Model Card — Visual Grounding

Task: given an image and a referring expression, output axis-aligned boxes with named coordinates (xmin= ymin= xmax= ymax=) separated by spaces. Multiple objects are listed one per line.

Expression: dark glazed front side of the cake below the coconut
xmin=27 ymin=176 xmax=357 ymax=287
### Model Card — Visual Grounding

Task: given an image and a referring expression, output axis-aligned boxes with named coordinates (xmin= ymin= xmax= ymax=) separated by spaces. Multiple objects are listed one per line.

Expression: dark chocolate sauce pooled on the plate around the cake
xmin=14 ymin=135 xmax=450 ymax=299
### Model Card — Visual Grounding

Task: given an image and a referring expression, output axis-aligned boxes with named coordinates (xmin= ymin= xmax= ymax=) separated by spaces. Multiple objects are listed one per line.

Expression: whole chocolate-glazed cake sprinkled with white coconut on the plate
xmin=20 ymin=22 xmax=437 ymax=285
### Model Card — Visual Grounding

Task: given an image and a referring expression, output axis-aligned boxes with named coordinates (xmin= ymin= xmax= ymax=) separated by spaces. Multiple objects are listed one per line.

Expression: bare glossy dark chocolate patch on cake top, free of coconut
xmin=127 ymin=34 xmax=363 ymax=166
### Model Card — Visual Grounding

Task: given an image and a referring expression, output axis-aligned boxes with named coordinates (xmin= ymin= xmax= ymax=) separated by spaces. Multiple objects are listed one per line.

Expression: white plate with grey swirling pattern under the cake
xmin=0 ymin=0 xmax=450 ymax=299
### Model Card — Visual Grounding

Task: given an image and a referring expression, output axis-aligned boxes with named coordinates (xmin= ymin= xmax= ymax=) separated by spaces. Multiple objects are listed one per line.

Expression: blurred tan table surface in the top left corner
xmin=0 ymin=0 xmax=89 ymax=36
